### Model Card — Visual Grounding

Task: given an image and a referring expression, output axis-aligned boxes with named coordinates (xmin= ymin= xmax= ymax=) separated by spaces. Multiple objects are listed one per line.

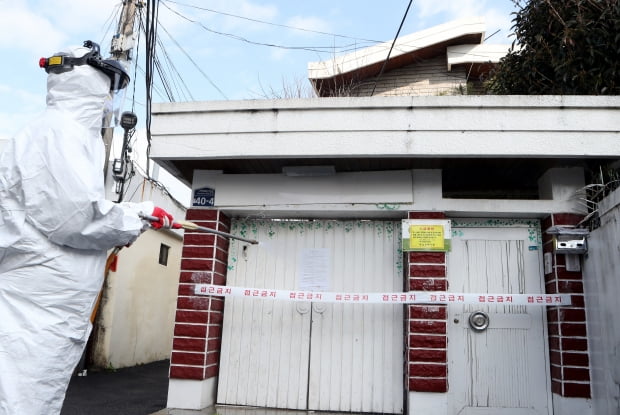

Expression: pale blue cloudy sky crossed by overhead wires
xmin=0 ymin=0 xmax=515 ymax=202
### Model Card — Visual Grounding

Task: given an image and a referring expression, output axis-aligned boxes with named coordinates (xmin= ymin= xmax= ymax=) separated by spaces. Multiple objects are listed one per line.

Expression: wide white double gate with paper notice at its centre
xmin=217 ymin=220 xmax=404 ymax=413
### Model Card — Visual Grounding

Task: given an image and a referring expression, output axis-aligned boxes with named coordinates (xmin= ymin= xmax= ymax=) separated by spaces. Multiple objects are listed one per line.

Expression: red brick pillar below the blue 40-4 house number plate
xmin=170 ymin=209 xmax=230 ymax=380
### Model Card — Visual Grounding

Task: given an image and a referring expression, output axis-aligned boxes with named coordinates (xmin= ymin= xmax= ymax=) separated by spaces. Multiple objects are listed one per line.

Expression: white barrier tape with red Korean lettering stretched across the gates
xmin=194 ymin=284 xmax=572 ymax=306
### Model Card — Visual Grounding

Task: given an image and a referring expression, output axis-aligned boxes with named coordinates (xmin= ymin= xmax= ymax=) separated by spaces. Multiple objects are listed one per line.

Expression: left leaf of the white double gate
xmin=217 ymin=221 xmax=310 ymax=409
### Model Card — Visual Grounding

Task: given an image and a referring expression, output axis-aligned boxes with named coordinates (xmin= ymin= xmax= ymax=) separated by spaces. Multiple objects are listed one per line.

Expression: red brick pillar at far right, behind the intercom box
xmin=543 ymin=214 xmax=591 ymax=398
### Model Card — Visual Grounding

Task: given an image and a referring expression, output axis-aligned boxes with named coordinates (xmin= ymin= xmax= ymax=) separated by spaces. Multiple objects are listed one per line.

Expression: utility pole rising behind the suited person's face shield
xmin=102 ymin=0 xmax=144 ymax=180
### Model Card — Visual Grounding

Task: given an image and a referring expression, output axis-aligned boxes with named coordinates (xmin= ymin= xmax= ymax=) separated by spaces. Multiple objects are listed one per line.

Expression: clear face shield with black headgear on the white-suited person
xmin=39 ymin=40 xmax=129 ymax=128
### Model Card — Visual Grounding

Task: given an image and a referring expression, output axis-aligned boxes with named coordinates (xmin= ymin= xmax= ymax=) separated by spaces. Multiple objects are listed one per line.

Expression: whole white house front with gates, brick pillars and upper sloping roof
xmin=151 ymin=17 xmax=620 ymax=415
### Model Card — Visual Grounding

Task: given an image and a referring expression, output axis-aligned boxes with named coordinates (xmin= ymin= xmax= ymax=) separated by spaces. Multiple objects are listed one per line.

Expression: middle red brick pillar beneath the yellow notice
xmin=406 ymin=212 xmax=448 ymax=392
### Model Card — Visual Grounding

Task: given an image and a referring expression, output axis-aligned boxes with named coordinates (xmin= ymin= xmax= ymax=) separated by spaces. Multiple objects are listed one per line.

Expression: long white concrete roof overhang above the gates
xmin=151 ymin=96 xmax=620 ymax=199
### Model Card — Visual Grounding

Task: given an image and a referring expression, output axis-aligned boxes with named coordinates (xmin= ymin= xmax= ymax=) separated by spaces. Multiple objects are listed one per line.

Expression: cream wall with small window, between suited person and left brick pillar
xmin=91 ymin=167 xmax=185 ymax=368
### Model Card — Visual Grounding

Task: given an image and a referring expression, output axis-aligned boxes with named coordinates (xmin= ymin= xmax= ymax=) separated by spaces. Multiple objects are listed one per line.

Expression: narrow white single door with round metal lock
xmin=448 ymin=220 xmax=552 ymax=415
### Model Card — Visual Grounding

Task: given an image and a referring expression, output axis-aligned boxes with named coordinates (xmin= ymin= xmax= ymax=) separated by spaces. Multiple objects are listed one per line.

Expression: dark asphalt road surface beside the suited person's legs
xmin=61 ymin=360 xmax=170 ymax=415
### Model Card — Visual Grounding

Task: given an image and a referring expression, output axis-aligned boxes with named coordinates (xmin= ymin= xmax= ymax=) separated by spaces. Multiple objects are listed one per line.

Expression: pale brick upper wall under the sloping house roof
xmin=349 ymin=56 xmax=466 ymax=97
